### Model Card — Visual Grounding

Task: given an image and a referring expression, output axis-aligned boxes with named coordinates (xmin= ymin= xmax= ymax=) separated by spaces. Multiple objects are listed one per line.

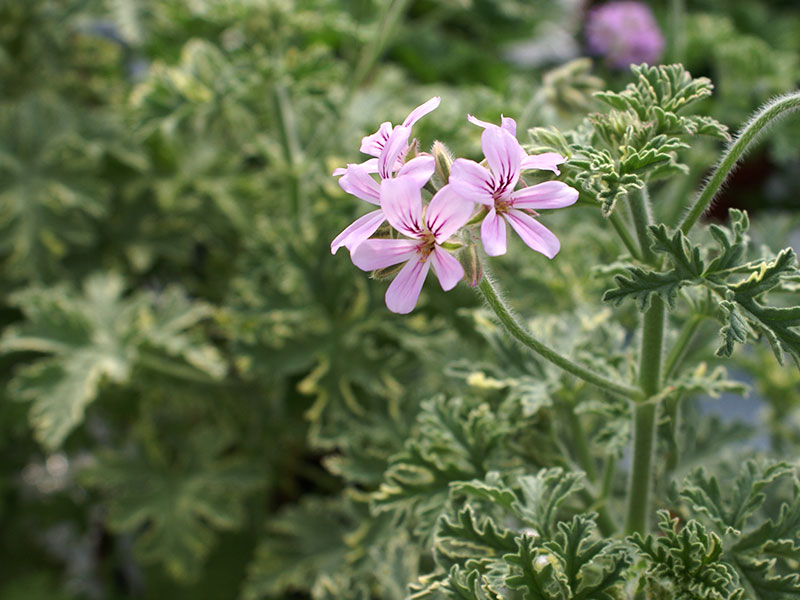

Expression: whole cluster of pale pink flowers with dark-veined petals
xmin=331 ymin=97 xmax=578 ymax=314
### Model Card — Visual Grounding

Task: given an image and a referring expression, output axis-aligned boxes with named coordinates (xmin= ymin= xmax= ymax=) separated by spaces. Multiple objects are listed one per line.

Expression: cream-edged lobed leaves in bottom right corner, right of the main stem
xmin=628 ymin=460 xmax=800 ymax=600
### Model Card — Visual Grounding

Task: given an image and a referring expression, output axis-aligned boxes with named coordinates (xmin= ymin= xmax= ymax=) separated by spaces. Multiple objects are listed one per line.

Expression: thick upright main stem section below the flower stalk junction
xmin=625 ymin=402 xmax=658 ymax=534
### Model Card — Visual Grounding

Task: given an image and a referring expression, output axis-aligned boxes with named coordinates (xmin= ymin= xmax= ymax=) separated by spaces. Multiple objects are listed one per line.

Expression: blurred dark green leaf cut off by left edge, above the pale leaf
xmin=0 ymin=94 xmax=108 ymax=281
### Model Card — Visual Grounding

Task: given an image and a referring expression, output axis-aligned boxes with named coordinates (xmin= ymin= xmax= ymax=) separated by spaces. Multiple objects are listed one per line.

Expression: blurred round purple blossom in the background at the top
xmin=586 ymin=1 xmax=664 ymax=69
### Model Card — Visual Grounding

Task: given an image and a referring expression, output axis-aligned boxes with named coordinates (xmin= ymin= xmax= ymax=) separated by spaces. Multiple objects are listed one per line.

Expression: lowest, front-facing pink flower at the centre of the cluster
xmin=352 ymin=176 xmax=472 ymax=314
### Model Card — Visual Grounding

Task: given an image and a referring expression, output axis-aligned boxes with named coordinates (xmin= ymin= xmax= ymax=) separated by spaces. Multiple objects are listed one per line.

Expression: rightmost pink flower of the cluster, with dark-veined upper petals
xmin=448 ymin=116 xmax=578 ymax=258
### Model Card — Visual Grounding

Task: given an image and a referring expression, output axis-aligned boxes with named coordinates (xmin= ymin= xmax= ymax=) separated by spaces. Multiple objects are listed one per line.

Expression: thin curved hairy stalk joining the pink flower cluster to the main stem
xmin=478 ymin=276 xmax=641 ymax=399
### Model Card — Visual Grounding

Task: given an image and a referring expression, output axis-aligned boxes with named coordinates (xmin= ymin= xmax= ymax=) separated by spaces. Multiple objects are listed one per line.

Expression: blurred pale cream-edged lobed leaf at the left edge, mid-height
xmin=0 ymin=275 xmax=226 ymax=449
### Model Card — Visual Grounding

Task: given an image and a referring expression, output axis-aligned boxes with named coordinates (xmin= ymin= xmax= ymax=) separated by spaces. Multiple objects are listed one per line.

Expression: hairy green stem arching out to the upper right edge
xmin=680 ymin=92 xmax=800 ymax=233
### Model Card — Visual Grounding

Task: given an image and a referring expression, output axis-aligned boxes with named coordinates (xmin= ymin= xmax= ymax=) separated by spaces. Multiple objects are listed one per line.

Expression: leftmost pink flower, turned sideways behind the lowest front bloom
xmin=331 ymin=96 xmax=440 ymax=254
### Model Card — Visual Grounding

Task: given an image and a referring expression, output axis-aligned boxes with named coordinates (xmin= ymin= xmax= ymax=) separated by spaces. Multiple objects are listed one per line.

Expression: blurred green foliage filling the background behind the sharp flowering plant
xmin=0 ymin=0 xmax=800 ymax=600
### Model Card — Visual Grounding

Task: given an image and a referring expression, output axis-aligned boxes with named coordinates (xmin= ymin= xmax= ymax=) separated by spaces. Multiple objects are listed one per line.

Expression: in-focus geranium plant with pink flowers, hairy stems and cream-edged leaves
xmin=332 ymin=64 xmax=800 ymax=600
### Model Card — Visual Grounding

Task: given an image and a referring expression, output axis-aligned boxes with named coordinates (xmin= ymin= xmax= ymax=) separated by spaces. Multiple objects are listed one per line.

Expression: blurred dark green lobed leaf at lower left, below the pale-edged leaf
xmin=82 ymin=429 xmax=263 ymax=580
